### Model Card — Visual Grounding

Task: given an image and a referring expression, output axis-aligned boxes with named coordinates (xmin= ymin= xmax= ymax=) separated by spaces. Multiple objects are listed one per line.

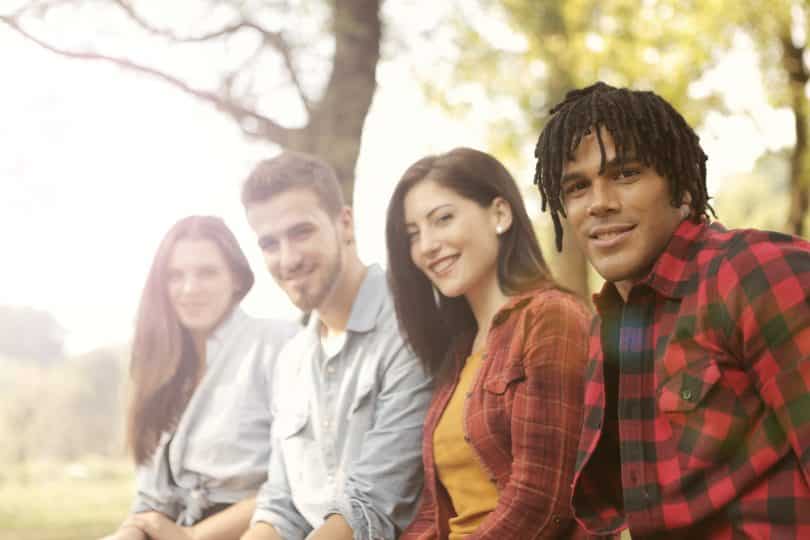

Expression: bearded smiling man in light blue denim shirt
xmin=242 ymin=152 xmax=431 ymax=540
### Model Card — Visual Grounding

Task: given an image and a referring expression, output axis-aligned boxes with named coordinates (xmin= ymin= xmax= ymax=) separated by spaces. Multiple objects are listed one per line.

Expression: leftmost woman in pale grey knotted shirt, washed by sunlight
xmin=100 ymin=216 xmax=295 ymax=540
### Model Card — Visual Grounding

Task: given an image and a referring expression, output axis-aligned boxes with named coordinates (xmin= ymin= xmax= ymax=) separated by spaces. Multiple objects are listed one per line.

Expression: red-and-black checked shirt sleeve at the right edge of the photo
xmin=718 ymin=233 xmax=810 ymax=483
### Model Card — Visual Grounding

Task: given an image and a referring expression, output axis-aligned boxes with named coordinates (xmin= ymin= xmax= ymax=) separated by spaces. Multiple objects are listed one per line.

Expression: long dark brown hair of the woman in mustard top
xmin=385 ymin=148 xmax=552 ymax=375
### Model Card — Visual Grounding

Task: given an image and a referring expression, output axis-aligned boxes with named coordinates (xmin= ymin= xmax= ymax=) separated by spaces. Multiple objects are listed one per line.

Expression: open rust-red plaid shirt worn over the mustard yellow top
xmin=400 ymin=287 xmax=591 ymax=540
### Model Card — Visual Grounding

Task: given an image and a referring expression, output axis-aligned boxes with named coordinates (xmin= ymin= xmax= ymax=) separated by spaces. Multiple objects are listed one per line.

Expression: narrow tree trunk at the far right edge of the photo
xmin=780 ymin=29 xmax=810 ymax=236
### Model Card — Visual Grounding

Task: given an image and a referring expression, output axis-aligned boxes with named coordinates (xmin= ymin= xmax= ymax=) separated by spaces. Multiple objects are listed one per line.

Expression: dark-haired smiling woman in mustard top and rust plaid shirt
xmin=386 ymin=148 xmax=590 ymax=540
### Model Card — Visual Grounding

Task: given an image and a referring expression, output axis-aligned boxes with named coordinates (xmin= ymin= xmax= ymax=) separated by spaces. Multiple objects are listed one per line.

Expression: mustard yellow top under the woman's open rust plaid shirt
xmin=433 ymin=352 xmax=498 ymax=540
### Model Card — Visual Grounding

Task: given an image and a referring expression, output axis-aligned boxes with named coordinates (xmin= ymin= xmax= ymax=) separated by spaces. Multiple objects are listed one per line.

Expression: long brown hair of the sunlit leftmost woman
xmin=127 ymin=216 xmax=254 ymax=464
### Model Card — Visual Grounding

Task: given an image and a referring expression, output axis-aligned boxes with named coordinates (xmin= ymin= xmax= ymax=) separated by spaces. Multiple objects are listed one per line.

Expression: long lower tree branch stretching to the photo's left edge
xmin=0 ymin=15 xmax=292 ymax=146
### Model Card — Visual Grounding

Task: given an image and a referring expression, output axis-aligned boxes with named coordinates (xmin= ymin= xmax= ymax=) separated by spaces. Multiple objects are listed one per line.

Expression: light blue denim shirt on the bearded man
xmin=252 ymin=266 xmax=432 ymax=540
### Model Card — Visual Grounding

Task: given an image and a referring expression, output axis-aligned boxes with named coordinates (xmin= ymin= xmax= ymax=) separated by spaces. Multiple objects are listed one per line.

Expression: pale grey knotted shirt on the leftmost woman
xmin=132 ymin=308 xmax=298 ymax=525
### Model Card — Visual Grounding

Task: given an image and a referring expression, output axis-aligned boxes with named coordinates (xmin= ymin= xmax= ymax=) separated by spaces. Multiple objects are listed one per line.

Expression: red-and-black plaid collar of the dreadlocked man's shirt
xmin=593 ymin=219 xmax=709 ymax=312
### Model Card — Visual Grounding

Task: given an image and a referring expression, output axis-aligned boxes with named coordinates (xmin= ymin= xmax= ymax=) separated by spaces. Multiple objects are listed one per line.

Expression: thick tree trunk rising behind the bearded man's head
xmin=288 ymin=0 xmax=382 ymax=205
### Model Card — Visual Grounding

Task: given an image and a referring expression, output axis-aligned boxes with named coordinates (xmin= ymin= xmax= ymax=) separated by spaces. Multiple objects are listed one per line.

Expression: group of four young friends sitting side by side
xmin=101 ymin=83 xmax=810 ymax=540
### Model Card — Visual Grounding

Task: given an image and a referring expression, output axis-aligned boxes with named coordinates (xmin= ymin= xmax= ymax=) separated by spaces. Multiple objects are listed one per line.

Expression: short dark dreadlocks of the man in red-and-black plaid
xmin=534 ymin=81 xmax=716 ymax=251
